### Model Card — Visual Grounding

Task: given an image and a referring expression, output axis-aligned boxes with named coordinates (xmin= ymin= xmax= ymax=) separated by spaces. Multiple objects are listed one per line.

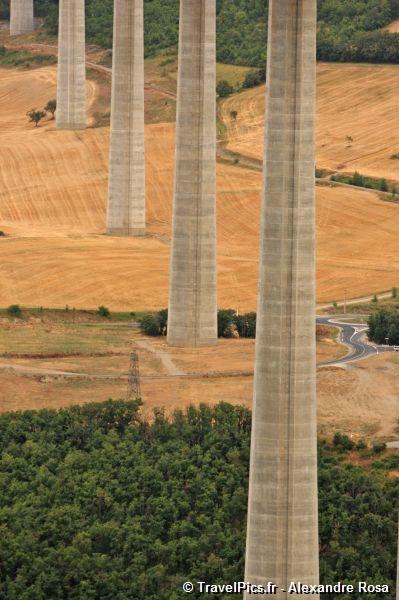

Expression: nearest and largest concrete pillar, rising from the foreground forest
xmin=245 ymin=0 xmax=319 ymax=599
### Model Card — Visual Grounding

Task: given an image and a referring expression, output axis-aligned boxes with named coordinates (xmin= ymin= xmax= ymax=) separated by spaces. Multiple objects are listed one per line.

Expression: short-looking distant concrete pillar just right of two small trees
xmin=56 ymin=0 xmax=86 ymax=129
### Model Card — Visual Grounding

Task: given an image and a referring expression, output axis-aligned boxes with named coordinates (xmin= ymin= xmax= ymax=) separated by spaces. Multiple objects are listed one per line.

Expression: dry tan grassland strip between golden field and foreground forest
xmin=0 ymin=319 xmax=399 ymax=437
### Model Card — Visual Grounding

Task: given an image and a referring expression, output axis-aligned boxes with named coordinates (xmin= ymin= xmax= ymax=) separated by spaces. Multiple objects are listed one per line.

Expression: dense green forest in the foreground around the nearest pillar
xmin=0 ymin=401 xmax=399 ymax=600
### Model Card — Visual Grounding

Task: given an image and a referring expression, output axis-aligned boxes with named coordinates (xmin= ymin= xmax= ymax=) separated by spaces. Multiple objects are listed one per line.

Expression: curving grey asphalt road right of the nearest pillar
xmin=316 ymin=315 xmax=395 ymax=367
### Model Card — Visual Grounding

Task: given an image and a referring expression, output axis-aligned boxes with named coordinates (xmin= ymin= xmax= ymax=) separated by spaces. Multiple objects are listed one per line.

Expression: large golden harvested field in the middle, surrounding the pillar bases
xmin=0 ymin=67 xmax=399 ymax=310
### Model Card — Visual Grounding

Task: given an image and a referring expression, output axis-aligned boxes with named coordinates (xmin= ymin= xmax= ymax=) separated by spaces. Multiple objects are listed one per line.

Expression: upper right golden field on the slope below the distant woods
xmin=220 ymin=63 xmax=399 ymax=182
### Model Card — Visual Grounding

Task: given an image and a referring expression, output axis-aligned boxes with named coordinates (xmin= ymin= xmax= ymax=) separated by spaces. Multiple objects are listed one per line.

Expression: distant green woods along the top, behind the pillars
xmin=0 ymin=0 xmax=399 ymax=68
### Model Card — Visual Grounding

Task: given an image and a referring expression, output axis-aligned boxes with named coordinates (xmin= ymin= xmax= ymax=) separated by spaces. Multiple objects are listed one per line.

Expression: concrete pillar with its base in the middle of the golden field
xmin=107 ymin=0 xmax=145 ymax=236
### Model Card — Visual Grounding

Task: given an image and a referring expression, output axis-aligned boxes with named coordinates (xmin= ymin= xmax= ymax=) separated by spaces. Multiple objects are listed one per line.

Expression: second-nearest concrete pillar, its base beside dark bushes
xmin=168 ymin=0 xmax=217 ymax=347
